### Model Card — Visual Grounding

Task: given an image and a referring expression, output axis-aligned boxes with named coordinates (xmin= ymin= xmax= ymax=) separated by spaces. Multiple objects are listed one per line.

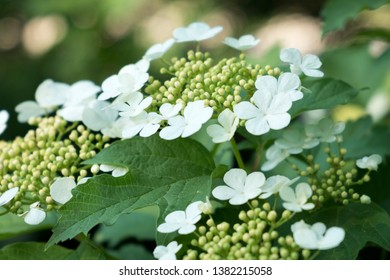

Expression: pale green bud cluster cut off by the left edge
xmin=0 ymin=116 xmax=109 ymax=214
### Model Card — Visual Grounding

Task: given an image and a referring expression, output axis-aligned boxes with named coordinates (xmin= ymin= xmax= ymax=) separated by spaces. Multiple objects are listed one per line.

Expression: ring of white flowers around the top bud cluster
xmin=13 ymin=22 xmax=322 ymax=147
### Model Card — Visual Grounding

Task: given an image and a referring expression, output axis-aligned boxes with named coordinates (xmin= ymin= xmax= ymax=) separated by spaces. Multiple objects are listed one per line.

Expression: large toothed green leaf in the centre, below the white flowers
xmin=48 ymin=136 xmax=215 ymax=246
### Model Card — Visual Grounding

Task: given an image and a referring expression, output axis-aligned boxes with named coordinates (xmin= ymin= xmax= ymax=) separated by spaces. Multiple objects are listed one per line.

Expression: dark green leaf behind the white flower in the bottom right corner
xmin=305 ymin=203 xmax=390 ymax=260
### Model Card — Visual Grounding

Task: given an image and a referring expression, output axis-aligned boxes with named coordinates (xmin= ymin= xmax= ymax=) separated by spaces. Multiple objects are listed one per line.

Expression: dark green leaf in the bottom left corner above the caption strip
xmin=0 ymin=242 xmax=72 ymax=260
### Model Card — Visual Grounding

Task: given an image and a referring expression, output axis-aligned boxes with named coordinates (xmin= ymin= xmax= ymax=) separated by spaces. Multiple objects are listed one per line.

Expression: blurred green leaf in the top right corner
xmin=321 ymin=0 xmax=389 ymax=34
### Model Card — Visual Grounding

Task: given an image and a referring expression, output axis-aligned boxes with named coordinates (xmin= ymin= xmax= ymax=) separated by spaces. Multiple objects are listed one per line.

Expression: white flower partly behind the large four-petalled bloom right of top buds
xmin=255 ymin=73 xmax=303 ymax=101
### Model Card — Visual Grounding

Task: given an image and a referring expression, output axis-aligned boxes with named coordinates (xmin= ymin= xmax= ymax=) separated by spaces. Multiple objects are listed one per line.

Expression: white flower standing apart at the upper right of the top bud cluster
xmin=280 ymin=48 xmax=324 ymax=77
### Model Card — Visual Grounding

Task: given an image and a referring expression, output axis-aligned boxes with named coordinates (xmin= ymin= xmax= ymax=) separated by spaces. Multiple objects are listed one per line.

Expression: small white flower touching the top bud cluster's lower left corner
xmin=115 ymin=92 xmax=153 ymax=117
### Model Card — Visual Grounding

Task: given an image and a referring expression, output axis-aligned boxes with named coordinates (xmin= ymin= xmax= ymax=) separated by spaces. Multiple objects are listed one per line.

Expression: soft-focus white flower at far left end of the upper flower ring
xmin=15 ymin=80 xmax=69 ymax=123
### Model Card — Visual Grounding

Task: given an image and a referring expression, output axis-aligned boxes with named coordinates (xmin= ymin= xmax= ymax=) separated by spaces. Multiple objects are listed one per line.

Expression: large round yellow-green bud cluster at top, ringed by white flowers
xmin=145 ymin=50 xmax=280 ymax=113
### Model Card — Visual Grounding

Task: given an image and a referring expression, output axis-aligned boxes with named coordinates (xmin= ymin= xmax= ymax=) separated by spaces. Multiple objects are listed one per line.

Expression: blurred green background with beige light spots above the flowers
xmin=0 ymin=0 xmax=390 ymax=139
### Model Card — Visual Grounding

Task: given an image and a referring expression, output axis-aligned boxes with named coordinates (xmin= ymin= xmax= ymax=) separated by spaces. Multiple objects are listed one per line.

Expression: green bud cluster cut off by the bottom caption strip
xmin=183 ymin=200 xmax=310 ymax=260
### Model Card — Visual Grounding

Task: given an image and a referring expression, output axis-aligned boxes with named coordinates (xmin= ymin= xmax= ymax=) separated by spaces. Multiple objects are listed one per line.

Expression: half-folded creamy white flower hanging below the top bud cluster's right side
xmin=207 ymin=109 xmax=239 ymax=143
